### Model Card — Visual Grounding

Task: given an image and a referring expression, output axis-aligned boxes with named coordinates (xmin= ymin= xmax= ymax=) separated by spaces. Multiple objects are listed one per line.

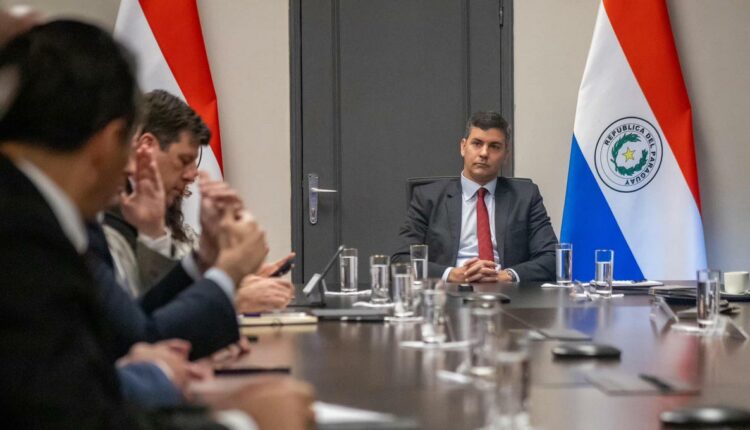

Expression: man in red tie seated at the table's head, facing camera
xmin=393 ymin=112 xmax=557 ymax=283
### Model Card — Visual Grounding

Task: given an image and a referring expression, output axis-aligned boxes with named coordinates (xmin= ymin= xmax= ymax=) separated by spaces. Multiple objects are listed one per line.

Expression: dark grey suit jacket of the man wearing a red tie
xmin=393 ymin=177 xmax=557 ymax=281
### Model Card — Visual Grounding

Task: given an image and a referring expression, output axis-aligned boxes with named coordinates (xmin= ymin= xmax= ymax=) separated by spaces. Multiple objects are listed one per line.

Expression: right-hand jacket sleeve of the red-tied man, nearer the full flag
xmin=509 ymin=185 xmax=557 ymax=281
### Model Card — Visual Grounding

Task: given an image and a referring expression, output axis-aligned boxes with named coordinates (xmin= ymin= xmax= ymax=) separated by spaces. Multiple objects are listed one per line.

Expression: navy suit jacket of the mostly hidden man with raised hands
xmin=87 ymin=223 xmax=239 ymax=359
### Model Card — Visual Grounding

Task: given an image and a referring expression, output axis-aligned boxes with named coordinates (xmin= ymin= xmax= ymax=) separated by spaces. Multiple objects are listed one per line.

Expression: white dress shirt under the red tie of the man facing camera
xmin=443 ymin=172 xmax=520 ymax=280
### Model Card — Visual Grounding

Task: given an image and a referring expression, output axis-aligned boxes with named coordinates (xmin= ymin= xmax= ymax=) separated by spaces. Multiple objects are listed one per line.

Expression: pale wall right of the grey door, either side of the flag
xmin=514 ymin=0 xmax=750 ymax=270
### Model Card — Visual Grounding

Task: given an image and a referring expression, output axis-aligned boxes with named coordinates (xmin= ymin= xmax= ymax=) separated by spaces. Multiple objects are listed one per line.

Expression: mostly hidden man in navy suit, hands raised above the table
xmin=87 ymin=143 xmax=265 ymax=358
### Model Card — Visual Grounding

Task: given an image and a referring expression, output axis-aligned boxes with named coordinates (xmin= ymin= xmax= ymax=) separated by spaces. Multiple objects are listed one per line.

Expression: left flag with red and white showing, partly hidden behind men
xmin=115 ymin=0 xmax=223 ymax=228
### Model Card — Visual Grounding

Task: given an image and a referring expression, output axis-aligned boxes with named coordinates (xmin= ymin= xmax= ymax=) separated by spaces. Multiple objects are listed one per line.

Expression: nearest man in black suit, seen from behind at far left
xmin=0 ymin=21 xmax=311 ymax=429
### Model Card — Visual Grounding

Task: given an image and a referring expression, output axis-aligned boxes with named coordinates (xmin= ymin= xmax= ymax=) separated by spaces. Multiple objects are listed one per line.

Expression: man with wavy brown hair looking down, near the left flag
xmin=104 ymin=90 xmax=294 ymax=312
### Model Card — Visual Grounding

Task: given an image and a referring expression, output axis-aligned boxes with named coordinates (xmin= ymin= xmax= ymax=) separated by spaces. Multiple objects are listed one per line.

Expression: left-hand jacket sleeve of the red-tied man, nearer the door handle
xmin=391 ymin=187 xmax=449 ymax=278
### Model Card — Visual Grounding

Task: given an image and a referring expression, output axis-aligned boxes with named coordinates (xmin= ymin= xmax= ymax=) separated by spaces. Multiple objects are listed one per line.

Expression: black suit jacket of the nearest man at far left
xmin=0 ymin=156 xmax=138 ymax=428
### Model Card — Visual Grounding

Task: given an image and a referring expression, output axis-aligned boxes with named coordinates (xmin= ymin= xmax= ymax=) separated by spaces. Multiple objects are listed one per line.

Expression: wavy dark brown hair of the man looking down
xmin=141 ymin=90 xmax=211 ymax=149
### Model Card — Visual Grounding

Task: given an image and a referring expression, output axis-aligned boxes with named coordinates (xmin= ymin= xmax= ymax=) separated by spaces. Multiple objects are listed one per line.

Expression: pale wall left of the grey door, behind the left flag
xmin=6 ymin=0 xmax=292 ymax=259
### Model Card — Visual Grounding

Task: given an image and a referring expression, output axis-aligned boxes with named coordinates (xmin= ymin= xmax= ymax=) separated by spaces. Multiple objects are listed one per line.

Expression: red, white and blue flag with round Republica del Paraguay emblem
xmin=561 ymin=0 xmax=706 ymax=281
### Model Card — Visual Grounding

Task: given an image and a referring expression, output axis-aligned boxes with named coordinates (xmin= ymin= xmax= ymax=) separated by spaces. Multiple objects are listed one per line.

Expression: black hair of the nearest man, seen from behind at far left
xmin=0 ymin=20 xmax=139 ymax=152
